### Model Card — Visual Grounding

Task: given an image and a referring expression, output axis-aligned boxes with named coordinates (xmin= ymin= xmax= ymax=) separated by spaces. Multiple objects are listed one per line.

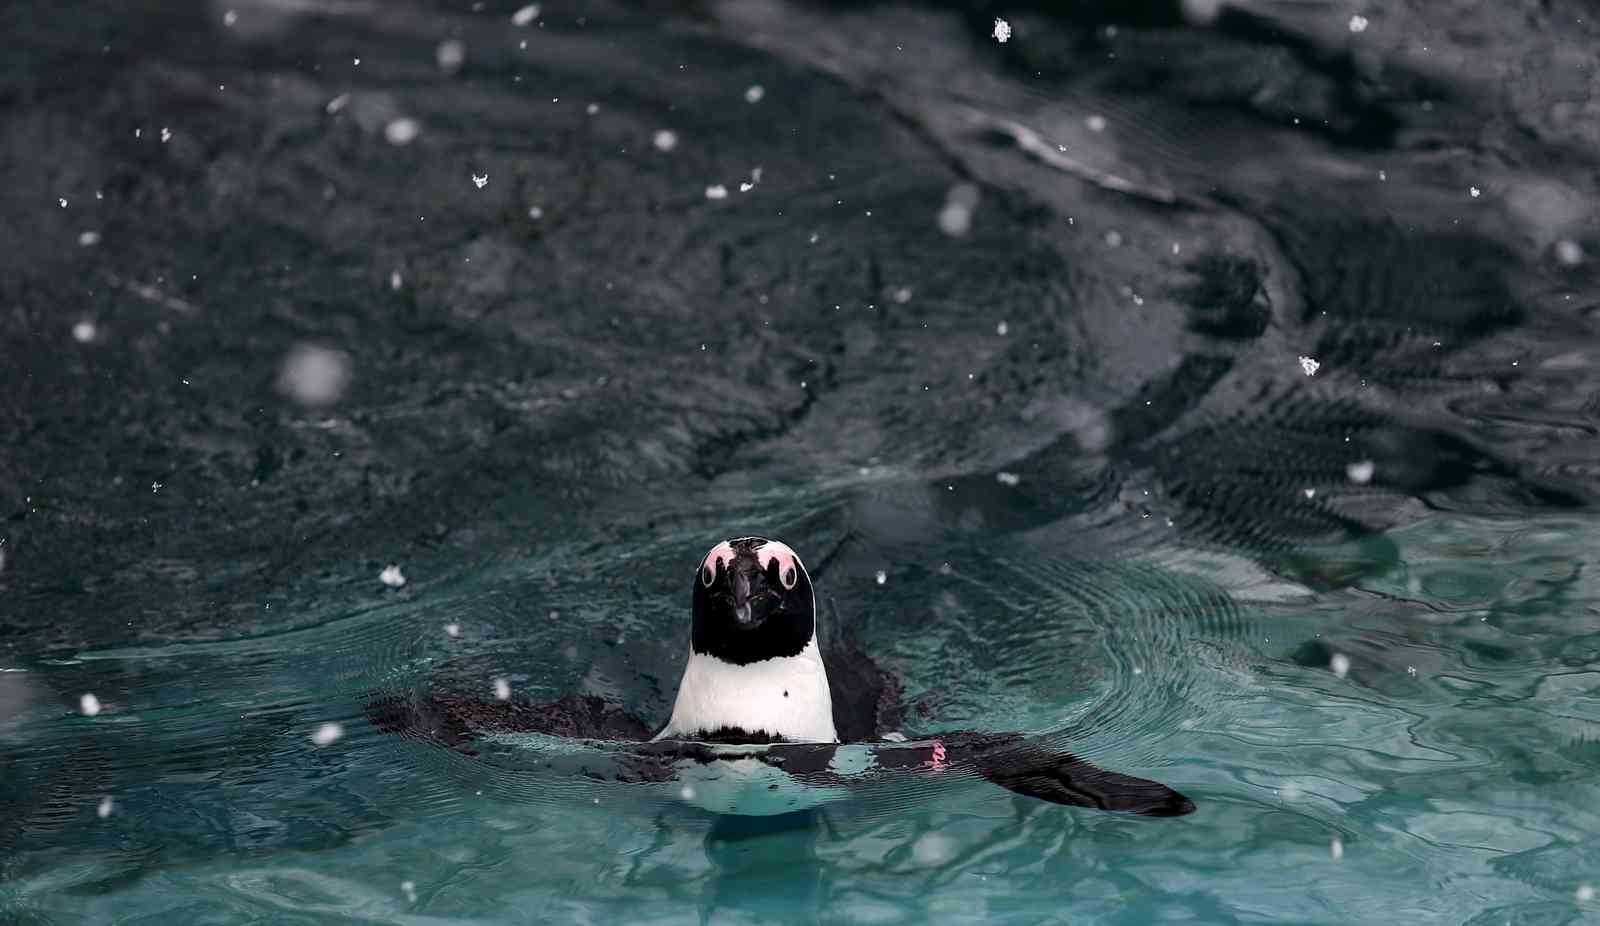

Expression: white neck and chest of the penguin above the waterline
xmin=656 ymin=640 xmax=838 ymax=742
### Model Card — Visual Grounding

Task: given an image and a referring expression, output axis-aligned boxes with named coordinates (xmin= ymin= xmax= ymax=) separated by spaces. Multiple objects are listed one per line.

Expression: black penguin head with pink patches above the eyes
xmin=690 ymin=537 xmax=816 ymax=665
